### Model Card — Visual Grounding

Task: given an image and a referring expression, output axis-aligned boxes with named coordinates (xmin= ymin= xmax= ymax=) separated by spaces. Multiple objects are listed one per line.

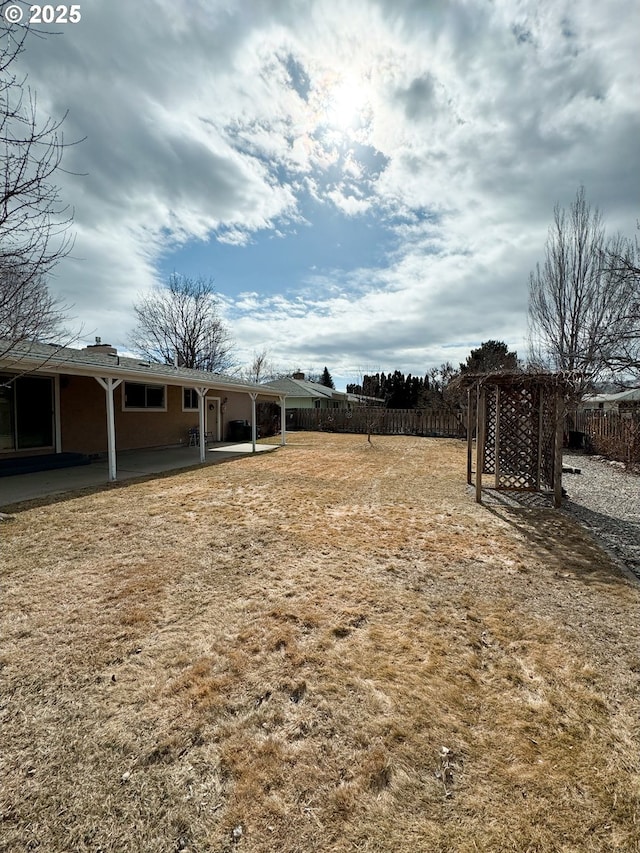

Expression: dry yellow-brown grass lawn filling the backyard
xmin=0 ymin=433 xmax=640 ymax=853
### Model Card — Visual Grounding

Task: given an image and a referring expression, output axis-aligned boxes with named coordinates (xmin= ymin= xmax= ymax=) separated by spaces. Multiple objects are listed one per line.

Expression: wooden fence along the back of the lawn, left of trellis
xmin=287 ymin=406 xmax=467 ymax=438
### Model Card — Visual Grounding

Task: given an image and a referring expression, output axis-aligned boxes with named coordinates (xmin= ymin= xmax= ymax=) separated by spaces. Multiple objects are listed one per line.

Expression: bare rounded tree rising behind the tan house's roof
xmin=130 ymin=273 xmax=233 ymax=373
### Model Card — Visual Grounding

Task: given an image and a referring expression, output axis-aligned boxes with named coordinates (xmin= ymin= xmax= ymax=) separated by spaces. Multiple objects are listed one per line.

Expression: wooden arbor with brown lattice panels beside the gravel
xmin=467 ymin=374 xmax=563 ymax=506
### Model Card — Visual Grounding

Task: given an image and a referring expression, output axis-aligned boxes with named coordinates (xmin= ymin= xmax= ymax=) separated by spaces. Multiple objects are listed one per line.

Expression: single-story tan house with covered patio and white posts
xmin=0 ymin=338 xmax=285 ymax=480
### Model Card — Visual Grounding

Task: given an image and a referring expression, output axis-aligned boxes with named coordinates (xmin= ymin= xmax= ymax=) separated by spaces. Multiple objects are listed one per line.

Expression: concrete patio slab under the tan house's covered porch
xmin=0 ymin=442 xmax=279 ymax=508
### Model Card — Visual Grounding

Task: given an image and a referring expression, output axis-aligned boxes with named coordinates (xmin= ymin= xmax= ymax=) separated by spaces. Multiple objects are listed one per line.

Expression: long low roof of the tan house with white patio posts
xmin=0 ymin=341 xmax=283 ymax=397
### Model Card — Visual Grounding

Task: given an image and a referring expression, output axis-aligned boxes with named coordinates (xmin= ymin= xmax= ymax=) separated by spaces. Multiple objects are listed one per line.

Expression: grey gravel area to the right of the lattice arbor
xmin=562 ymin=453 xmax=640 ymax=580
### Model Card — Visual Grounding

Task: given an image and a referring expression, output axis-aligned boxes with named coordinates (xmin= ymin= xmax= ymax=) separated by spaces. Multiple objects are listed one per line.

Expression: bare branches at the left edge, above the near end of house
xmin=0 ymin=16 xmax=78 ymax=352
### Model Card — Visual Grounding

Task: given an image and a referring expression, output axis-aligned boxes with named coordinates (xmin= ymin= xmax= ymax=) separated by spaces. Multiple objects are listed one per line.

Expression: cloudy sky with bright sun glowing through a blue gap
xmin=11 ymin=0 xmax=640 ymax=387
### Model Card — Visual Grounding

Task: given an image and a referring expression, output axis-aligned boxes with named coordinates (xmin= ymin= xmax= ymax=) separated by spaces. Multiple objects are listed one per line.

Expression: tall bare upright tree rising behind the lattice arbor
xmin=529 ymin=187 xmax=631 ymax=393
